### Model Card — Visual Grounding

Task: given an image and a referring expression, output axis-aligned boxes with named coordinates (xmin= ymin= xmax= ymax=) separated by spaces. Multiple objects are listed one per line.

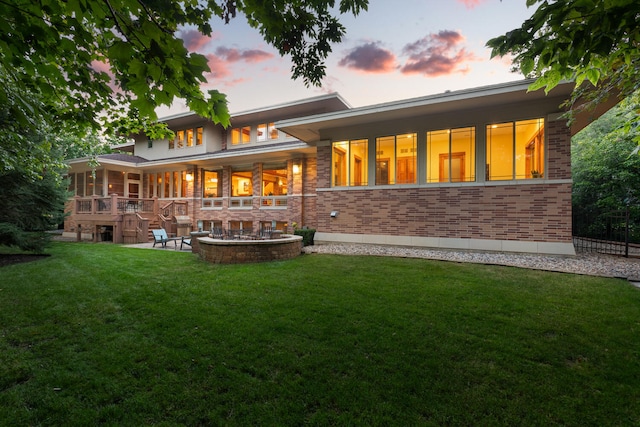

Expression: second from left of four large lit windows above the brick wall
xmin=376 ymin=133 xmax=417 ymax=185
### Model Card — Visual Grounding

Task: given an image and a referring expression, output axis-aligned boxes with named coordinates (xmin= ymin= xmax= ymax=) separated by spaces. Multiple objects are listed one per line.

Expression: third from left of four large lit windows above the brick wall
xmin=427 ymin=127 xmax=476 ymax=183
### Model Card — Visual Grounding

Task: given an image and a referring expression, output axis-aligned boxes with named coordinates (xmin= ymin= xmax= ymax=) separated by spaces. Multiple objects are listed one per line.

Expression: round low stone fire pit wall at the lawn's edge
xmin=198 ymin=234 xmax=302 ymax=264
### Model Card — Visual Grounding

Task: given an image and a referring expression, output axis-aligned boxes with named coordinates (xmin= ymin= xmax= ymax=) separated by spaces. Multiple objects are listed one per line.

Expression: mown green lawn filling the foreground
xmin=0 ymin=242 xmax=640 ymax=426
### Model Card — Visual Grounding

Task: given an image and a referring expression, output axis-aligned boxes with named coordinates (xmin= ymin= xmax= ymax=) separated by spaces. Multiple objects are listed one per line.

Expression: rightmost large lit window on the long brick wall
xmin=486 ymin=119 xmax=544 ymax=181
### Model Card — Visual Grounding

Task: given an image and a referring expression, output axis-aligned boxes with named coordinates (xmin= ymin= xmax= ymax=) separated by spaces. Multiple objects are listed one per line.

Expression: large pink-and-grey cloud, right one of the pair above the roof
xmin=401 ymin=31 xmax=477 ymax=77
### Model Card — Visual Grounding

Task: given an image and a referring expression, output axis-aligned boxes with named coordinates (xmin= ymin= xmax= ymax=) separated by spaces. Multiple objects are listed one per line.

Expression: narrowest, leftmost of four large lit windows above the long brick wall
xmin=331 ymin=139 xmax=369 ymax=187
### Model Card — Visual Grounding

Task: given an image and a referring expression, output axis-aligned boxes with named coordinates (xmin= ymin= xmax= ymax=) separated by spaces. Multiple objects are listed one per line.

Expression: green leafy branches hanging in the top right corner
xmin=487 ymin=0 xmax=640 ymax=143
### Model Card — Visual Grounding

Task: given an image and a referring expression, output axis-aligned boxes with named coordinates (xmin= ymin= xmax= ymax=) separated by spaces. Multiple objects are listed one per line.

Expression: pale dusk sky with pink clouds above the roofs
xmin=158 ymin=0 xmax=534 ymax=117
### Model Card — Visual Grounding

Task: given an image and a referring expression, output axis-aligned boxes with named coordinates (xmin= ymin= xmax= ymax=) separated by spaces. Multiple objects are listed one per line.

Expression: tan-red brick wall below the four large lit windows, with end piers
xmin=316 ymin=121 xmax=571 ymax=243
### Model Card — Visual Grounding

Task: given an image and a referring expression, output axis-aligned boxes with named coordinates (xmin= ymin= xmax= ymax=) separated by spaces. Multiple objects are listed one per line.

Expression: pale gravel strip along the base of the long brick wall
xmin=303 ymin=243 xmax=640 ymax=282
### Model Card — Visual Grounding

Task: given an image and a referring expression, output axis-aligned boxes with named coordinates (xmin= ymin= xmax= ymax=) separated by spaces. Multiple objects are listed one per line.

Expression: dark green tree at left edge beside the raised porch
xmin=0 ymin=76 xmax=114 ymax=252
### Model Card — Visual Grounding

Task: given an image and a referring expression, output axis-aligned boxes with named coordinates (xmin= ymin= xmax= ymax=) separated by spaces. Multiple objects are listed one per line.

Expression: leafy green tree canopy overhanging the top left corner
xmin=0 ymin=0 xmax=368 ymax=134
